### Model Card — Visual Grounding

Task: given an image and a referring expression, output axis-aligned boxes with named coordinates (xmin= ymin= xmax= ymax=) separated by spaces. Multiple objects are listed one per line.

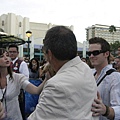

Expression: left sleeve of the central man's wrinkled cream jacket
xmin=27 ymin=81 xmax=67 ymax=120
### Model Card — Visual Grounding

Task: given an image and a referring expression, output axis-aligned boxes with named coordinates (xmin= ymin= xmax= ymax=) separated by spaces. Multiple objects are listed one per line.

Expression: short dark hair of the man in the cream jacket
xmin=43 ymin=26 xmax=77 ymax=60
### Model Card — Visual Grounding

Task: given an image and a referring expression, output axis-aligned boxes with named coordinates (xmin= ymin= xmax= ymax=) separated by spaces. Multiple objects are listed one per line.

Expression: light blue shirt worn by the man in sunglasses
xmin=96 ymin=65 xmax=120 ymax=120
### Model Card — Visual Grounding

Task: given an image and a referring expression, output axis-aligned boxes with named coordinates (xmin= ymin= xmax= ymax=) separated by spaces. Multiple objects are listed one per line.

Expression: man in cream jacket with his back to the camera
xmin=28 ymin=26 xmax=98 ymax=120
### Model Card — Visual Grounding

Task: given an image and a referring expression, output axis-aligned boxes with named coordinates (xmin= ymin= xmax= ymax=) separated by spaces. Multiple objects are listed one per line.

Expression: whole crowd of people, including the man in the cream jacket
xmin=0 ymin=26 xmax=120 ymax=120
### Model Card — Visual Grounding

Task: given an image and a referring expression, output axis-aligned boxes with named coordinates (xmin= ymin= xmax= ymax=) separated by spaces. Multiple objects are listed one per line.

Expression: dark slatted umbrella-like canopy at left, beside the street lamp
xmin=0 ymin=32 xmax=26 ymax=48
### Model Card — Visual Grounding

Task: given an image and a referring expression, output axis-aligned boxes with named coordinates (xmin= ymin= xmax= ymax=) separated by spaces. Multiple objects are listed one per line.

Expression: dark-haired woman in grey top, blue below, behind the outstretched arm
xmin=25 ymin=58 xmax=42 ymax=117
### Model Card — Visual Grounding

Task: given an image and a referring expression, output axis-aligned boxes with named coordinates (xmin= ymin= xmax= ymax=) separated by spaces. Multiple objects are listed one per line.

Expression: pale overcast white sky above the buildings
xmin=0 ymin=0 xmax=120 ymax=43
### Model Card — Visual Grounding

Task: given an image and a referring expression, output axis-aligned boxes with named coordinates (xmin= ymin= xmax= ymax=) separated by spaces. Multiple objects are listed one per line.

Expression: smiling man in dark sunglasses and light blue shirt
xmin=87 ymin=37 xmax=120 ymax=120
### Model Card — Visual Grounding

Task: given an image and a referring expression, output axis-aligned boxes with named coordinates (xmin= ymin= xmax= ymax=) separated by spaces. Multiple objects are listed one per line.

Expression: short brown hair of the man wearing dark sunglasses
xmin=89 ymin=37 xmax=110 ymax=62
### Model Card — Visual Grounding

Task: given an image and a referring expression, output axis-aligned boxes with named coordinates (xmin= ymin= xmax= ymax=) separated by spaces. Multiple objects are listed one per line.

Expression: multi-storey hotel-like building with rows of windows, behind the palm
xmin=86 ymin=24 xmax=120 ymax=43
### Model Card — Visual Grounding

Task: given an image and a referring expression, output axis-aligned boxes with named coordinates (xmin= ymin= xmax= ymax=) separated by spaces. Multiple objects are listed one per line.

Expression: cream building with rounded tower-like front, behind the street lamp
xmin=0 ymin=13 xmax=83 ymax=60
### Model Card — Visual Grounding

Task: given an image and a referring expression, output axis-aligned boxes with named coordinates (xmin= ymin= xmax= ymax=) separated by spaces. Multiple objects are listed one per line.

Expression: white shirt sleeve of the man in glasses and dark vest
xmin=19 ymin=61 xmax=29 ymax=78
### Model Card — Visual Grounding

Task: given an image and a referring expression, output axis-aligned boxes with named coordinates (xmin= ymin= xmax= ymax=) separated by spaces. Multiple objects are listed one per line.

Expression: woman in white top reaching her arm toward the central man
xmin=0 ymin=48 xmax=46 ymax=120
